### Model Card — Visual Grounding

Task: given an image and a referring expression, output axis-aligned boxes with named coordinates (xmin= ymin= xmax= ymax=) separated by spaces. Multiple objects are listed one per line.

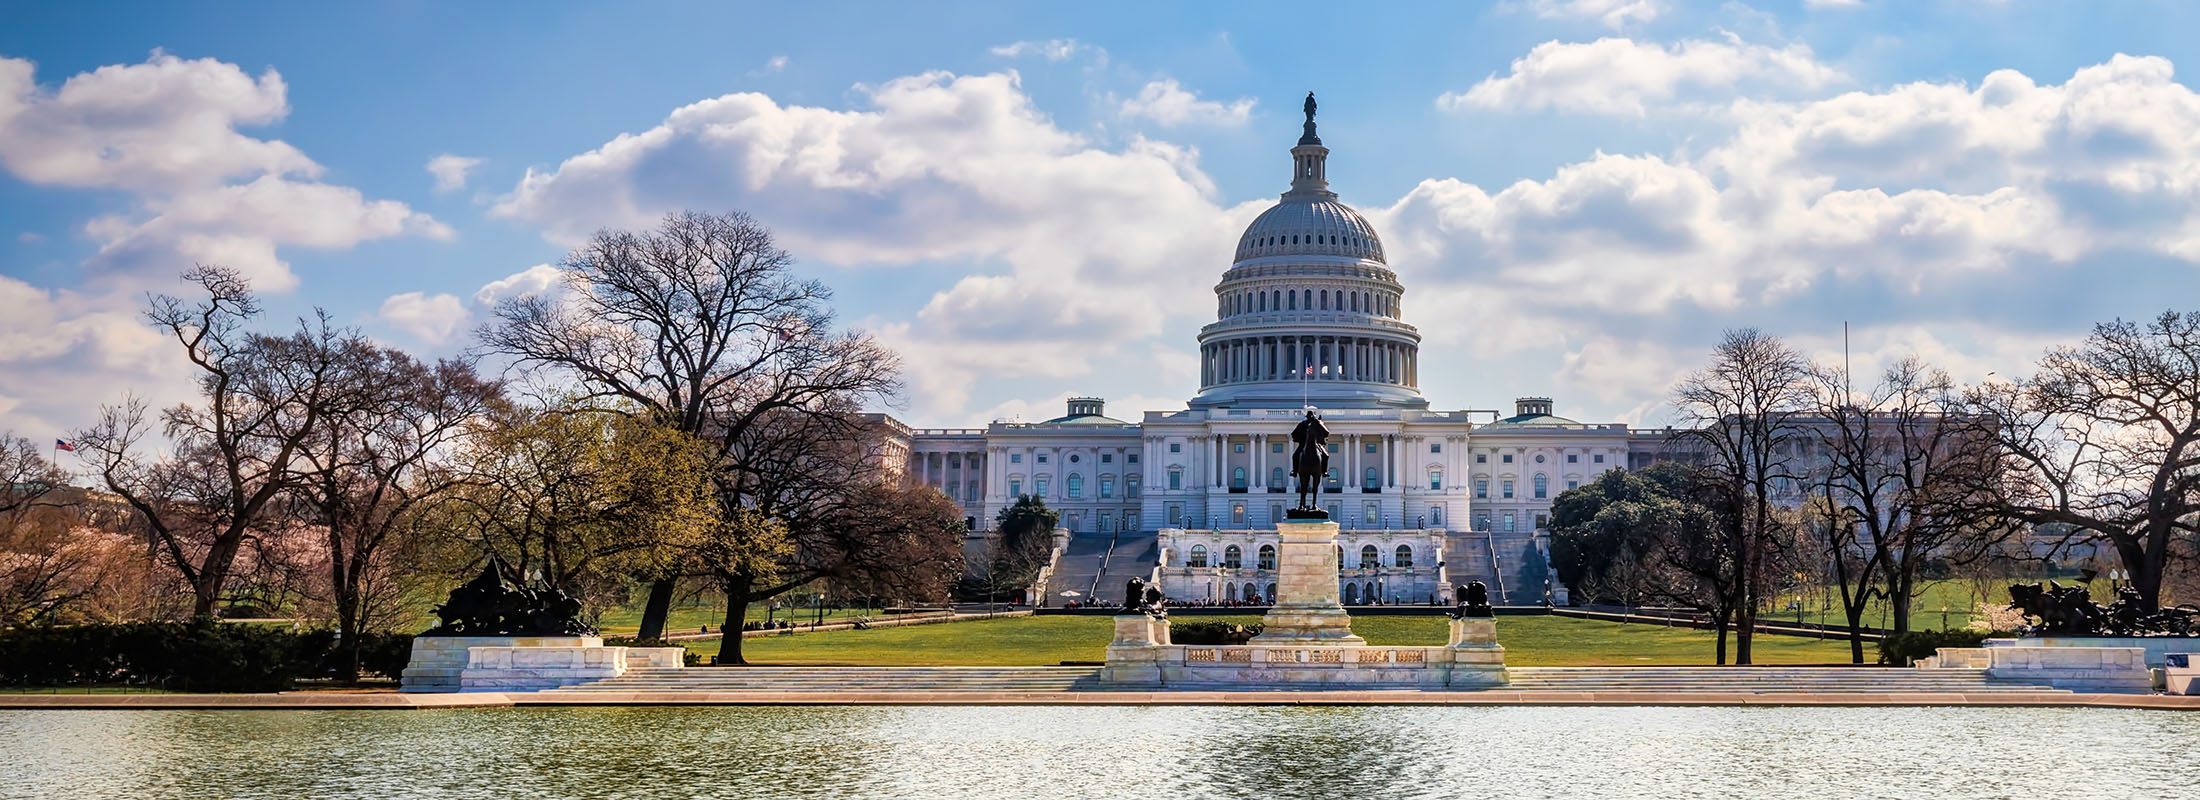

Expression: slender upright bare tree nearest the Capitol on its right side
xmin=1674 ymin=327 xmax=1811 ymax=664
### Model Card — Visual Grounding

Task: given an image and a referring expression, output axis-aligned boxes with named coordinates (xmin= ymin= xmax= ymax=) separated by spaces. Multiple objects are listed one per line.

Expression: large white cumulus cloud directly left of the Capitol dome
xmin=493 ymin=73 xmax=1283 ymax=415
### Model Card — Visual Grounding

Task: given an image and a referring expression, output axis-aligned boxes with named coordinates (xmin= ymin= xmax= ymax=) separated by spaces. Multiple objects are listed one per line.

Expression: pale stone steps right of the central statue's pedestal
xmin=1505 ymin=666 xmax=2068 ymax=695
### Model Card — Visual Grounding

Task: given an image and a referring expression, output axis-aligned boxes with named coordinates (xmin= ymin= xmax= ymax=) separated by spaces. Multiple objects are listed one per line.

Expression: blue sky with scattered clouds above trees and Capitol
xmin=0 ymin=0 xmax=2200 ymax=437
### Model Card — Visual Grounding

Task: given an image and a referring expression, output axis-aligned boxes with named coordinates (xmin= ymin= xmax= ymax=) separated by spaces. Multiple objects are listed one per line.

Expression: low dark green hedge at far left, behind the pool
xmin=0 ymin=622 xmax=411 ymax=692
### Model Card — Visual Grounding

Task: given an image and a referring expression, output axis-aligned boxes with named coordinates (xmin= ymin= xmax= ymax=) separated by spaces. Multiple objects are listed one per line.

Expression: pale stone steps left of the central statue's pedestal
xmin=554 ymin=666 xmax=1100 ymax=692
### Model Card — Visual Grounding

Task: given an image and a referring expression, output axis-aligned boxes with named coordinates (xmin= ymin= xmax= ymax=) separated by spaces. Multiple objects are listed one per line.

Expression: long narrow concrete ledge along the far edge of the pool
xmin=0 ymin=690 xmax=2200 ymax=710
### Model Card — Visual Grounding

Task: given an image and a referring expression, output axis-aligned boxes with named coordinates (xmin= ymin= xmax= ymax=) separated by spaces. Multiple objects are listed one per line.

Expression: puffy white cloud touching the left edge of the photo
xmin=0 ymin=51 xmax=451 ymax=443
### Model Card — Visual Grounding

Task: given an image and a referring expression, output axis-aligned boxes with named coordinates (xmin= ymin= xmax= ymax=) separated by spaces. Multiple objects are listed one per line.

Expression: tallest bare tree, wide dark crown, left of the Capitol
xmin=482 ymin=211 xmax=900 ymax=637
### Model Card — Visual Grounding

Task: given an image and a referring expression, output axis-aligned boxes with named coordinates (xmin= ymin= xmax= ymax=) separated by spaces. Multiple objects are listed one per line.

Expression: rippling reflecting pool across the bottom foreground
xmin=0 ymin=705 xmax=2200 ymax=800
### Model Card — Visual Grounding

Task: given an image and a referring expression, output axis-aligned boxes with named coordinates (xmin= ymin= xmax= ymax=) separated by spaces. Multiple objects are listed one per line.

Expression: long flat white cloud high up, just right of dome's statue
xmin=1437 ymin=37 xmax=1846 ymax=116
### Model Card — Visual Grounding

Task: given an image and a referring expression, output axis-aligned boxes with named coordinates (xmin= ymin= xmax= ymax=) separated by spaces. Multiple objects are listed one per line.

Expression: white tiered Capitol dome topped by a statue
xmin=1190 ymin=99 xmax=1428 ymax=409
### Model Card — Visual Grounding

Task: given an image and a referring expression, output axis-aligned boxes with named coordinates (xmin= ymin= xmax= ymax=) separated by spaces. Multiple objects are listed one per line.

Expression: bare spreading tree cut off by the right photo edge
xmin=1967 ymin=312 xmax=2200 ymax=604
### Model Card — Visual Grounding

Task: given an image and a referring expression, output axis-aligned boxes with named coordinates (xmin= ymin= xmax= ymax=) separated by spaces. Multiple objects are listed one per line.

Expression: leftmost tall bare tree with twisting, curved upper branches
xmin=75 ymin=266 xmax=345 ymax=618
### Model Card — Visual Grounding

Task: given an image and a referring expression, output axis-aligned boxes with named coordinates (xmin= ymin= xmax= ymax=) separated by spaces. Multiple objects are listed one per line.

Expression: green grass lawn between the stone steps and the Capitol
xmin=689 ymin=615 xmax=1870 ymax=666
